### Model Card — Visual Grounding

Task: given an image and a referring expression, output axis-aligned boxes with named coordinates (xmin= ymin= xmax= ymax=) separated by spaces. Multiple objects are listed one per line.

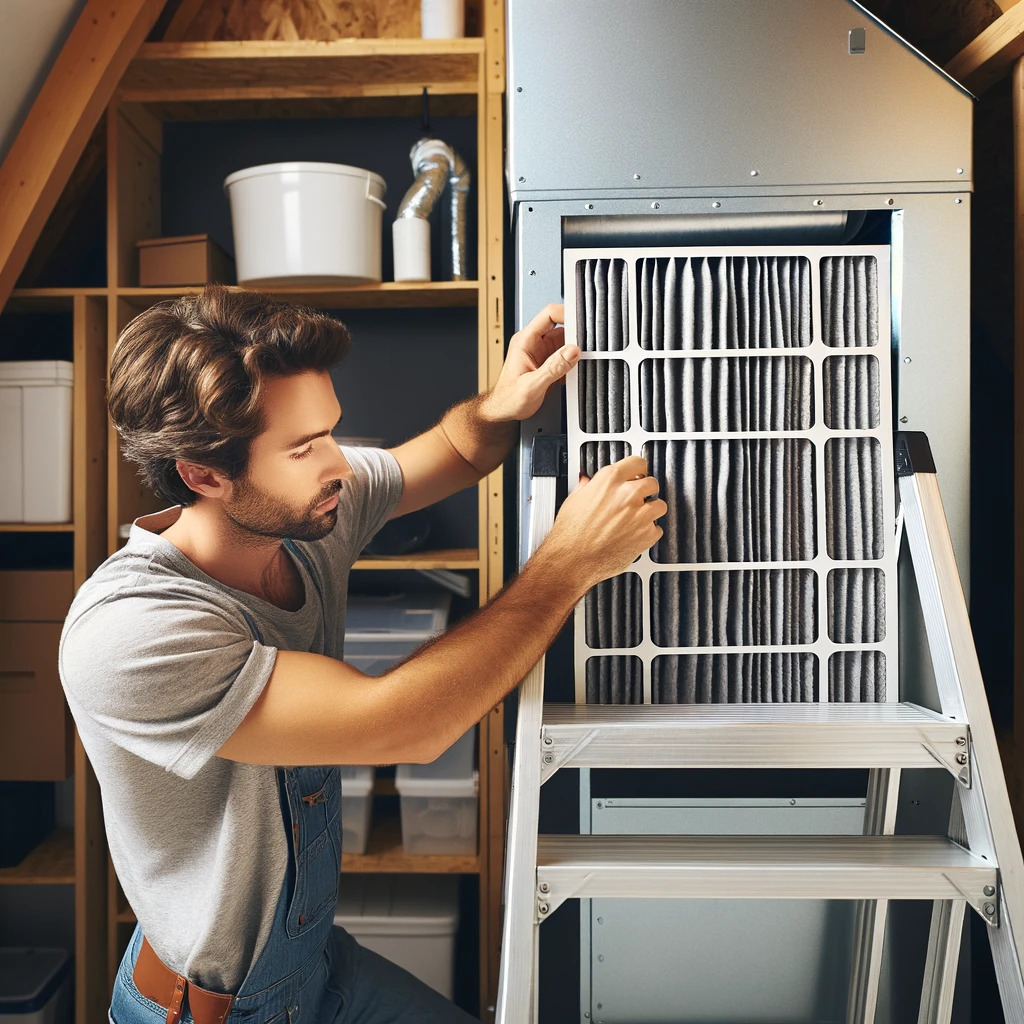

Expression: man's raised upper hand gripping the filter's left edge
xmin=480 ymin=304 xmax=580 ymax=423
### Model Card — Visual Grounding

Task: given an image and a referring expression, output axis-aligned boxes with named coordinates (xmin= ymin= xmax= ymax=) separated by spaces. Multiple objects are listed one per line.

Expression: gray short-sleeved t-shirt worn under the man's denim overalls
xmin=60 ymin=449 xmax=402 ymax=991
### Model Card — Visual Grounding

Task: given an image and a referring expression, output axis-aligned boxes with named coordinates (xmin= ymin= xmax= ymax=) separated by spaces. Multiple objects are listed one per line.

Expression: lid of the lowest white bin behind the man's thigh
xmin=334 ymin=872 xmax=459 ymax=935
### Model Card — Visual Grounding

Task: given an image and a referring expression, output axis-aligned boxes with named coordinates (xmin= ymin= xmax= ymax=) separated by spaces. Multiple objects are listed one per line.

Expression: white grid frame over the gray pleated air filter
xmin=562 ymin=245 xmax=899 ymax=703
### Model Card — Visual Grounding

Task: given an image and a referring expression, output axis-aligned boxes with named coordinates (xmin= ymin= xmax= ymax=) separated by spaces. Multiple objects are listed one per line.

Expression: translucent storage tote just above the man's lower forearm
xmin=345 ymin=591 xmax=452 ymax=676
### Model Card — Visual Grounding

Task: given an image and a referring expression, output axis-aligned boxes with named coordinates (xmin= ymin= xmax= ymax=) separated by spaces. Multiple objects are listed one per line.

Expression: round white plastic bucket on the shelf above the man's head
xmin=224 ymin=163 xmax=387 ymax=288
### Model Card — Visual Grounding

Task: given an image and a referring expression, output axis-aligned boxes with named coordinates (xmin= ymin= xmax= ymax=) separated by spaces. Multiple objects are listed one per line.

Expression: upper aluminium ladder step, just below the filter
xmin=541 ymin=703 xmax=970 ymax=784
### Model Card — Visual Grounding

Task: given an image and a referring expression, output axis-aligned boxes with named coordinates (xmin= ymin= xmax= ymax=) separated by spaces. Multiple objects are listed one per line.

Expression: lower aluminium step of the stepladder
xmin=537 ymin=836 xmax=997 ymax=924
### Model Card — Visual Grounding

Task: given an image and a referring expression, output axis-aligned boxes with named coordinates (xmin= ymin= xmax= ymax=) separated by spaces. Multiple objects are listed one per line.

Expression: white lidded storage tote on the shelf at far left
xmin=0 ymin=359 xmax=73 ymax=522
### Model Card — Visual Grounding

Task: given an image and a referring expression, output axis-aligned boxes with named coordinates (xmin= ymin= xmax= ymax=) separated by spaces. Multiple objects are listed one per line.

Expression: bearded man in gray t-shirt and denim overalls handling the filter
xmin=60 ymin=288 xmax=666 ymax=1024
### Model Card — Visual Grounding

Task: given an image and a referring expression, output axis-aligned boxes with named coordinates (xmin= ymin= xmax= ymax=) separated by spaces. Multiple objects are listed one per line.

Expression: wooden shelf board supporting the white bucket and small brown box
xmin=117 ymin=281 xmax=479 ymax=309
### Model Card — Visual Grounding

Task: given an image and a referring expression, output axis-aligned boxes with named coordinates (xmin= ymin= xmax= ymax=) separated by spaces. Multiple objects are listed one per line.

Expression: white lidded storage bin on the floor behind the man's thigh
xmin=334 ymin=874 xmax=459 ymax=999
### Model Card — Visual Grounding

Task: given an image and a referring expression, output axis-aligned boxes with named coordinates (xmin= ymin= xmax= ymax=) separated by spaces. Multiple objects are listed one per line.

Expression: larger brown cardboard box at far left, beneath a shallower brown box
xmin=0 ymin=623 xmax=75 ymax=781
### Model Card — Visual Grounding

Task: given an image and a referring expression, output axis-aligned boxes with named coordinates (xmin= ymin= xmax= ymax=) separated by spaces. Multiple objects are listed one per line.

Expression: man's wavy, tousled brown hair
xmin=108 ymin=286 xmax=349 ymax=505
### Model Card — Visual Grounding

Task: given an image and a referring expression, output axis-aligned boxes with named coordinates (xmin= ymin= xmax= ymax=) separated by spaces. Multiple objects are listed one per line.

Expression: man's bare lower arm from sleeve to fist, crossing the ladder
xmin=217 ymin=456 xmax=666 ymax=765
